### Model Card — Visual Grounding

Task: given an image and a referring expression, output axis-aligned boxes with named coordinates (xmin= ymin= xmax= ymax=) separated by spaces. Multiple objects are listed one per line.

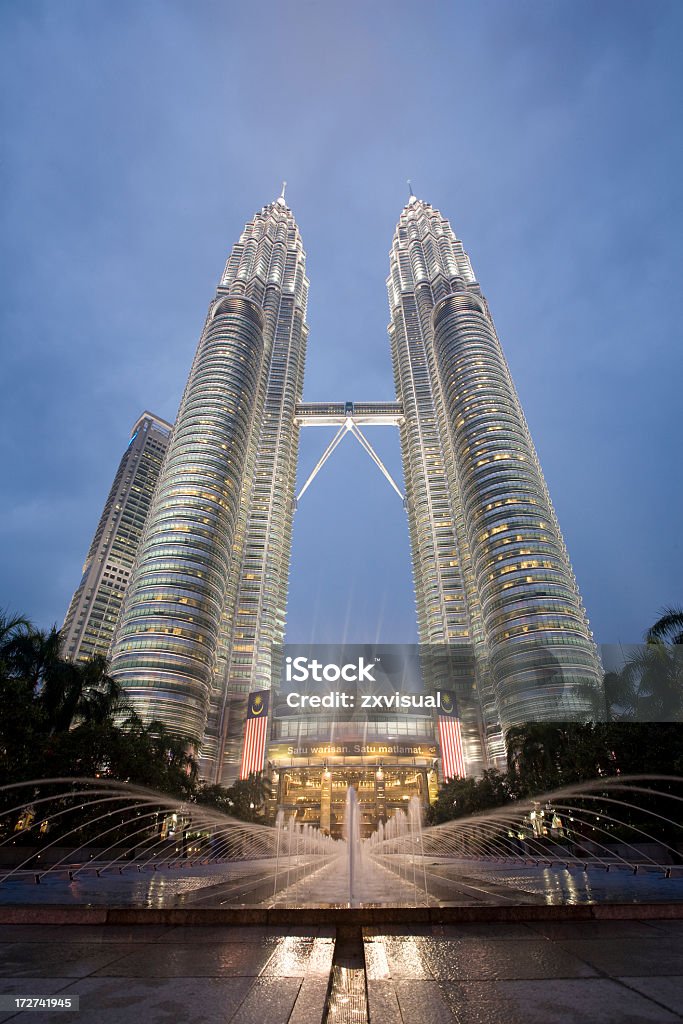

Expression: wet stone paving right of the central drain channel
xmin=365 ymin=921 xmax=683 ymax=1024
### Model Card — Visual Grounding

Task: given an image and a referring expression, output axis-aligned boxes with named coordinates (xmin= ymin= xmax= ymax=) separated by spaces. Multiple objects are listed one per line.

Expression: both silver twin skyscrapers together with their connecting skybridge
xmin=102 ymin=195 xmax=601 ymax=782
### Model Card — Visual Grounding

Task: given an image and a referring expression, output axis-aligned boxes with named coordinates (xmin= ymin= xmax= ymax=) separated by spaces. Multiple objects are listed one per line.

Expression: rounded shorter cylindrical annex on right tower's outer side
xmin=433 ymin=289 xmax=601 ymax=730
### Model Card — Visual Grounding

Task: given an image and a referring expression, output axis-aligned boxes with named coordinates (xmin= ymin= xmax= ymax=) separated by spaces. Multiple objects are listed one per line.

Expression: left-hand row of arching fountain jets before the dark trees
xmin=0 ymin=778 xmax=332 ymax=905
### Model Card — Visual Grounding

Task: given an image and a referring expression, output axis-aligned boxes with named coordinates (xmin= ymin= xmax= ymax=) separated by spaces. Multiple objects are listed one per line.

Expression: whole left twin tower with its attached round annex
xmin=112 ymin=199 xmax=308 ymax=761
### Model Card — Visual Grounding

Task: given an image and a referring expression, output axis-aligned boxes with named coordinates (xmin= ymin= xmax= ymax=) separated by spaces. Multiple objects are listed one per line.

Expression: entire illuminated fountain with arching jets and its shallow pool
xmin=0 ymin=776 xmax=683 ymax=906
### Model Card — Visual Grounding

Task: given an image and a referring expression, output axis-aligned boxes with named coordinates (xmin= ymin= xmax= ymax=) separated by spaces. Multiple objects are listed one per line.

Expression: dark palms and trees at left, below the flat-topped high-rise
xmin=0 ymin=613 xmax=197 ymax=797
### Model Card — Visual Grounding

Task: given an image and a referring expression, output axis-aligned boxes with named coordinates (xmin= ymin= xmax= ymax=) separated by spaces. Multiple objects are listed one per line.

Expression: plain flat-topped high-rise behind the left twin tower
xmin=61 ymin=413 xmax=172 ymax=662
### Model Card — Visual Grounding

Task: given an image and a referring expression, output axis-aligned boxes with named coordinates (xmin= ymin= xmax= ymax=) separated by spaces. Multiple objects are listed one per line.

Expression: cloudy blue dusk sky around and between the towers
xmin=0 ymin=0 xmax=683 ymax=642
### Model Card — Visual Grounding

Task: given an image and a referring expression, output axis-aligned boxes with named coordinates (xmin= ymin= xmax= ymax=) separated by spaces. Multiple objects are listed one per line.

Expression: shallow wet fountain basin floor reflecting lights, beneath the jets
xmin=0 ymin=857 xmax=683 ymax=907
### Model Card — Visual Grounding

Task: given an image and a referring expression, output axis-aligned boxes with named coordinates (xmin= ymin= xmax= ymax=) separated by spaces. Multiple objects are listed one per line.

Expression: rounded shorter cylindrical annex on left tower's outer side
xmin=112 ymin=292 xmax=263 ymax=744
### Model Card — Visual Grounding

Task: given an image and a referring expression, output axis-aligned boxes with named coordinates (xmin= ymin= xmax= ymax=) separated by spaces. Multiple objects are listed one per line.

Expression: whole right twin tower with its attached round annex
xmin=388 ymin=193 xmax=601 ymax=755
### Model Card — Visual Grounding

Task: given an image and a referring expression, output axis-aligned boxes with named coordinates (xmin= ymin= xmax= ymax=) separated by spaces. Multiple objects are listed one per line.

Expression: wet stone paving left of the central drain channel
xmin=0 ymin=926 xmax=334 ymax=1024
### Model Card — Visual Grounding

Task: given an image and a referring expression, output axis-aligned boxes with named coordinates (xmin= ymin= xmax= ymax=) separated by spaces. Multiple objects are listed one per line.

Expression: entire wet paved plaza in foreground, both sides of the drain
xmin=0 ymin=920 xmax=683 ymax=1024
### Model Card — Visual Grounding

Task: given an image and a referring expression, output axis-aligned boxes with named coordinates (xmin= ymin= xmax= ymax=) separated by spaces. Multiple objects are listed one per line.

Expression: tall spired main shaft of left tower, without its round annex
xmin=202 ymin=196 xmax=308 ymax=782
